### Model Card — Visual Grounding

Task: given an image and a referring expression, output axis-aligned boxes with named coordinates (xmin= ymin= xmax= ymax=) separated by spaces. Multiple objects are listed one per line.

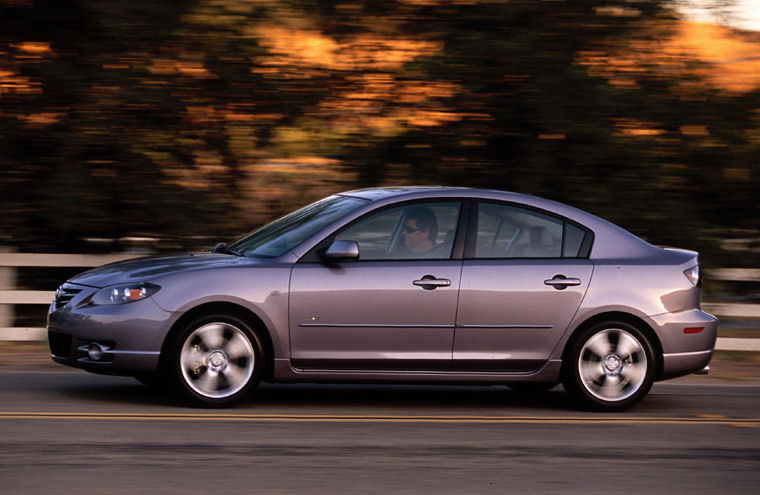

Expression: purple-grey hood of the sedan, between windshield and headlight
xmin=68 ymin=253 xmax=259 ymax=287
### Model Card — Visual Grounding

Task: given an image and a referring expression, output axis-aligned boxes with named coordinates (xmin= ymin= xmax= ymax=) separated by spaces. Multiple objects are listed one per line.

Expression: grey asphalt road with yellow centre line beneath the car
xmin=0 ymin=367 xmax=760 ymax=495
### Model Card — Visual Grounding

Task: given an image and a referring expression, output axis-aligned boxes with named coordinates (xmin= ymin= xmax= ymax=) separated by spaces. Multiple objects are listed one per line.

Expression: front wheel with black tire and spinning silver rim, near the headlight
xmin=166 ymin=314 xmax=265 ymax=407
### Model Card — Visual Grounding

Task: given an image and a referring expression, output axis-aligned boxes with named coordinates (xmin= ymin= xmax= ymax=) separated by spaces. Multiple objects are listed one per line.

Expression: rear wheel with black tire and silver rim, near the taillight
xmin=562 ymin=321 xmax=656 ymax=411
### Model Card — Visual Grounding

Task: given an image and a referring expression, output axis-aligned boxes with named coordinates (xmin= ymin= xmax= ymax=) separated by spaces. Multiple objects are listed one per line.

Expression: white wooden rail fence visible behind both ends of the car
xmin=0 ymin=252 xmax=760 ymax=351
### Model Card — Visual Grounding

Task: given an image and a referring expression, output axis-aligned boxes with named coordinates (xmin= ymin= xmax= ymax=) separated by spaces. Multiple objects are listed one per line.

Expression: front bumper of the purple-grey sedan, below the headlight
xmin=48 ymin=284 xmax=175 ymax=376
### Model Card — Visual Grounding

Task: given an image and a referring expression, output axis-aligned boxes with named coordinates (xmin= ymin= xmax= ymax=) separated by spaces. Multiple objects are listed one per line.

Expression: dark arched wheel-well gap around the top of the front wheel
xmin=158 ymin=302 xmax=274 ymax=381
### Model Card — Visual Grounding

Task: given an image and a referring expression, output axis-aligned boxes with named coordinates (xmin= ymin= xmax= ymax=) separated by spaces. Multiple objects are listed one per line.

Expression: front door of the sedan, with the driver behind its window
xmin=290 ymin=202 xmax=462 ymax=371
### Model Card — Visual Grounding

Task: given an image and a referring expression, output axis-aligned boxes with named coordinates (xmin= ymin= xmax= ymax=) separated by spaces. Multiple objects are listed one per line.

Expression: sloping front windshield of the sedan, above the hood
xmin=228 ymin=196 xmax=368 ymax=258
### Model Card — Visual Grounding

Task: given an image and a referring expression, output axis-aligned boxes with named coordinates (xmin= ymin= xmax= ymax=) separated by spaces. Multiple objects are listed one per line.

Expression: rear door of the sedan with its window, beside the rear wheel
xmin=453 ymin=202 xmax=593 ymax=372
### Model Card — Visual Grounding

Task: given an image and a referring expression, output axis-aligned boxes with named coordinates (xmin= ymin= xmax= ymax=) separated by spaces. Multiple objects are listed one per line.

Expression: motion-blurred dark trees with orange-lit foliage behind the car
xmin=0 ymin=0 xmax=760 ymax=338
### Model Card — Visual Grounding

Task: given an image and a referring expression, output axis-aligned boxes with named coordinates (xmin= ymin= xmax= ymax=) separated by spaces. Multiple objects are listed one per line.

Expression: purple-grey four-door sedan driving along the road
xmin=48 ymin=187 xmax=717 ymax=411
